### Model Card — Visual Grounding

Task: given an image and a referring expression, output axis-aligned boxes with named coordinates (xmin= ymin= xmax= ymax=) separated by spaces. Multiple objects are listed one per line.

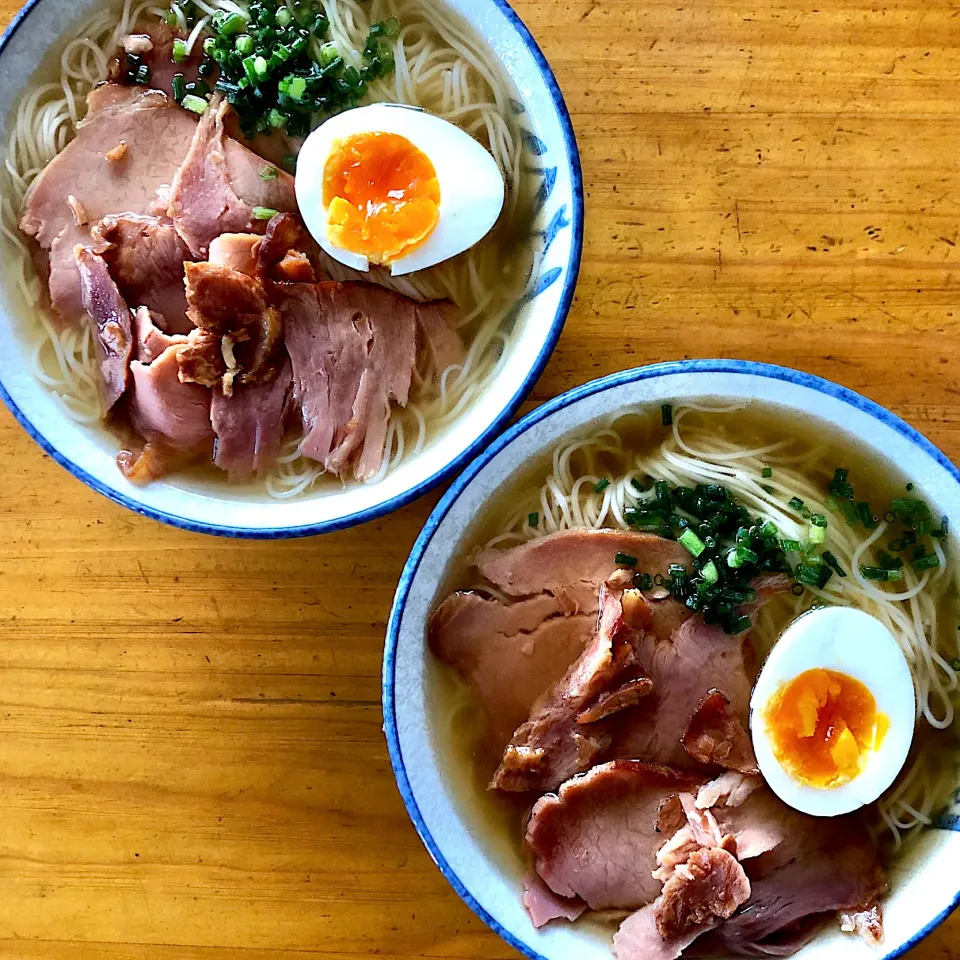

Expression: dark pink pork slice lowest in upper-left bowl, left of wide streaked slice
xmin=210 ymin=360 xmax=293 ymax=479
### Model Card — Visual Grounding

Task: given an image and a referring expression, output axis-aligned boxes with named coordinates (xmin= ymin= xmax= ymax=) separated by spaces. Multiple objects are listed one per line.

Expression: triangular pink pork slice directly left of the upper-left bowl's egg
xmin=166 ymin=102 xmax=297 ymax=260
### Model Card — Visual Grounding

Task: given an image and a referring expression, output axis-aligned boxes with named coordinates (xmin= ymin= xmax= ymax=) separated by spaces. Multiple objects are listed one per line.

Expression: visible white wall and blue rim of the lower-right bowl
xmin=383 ymin=360 xmax=960 ymax=960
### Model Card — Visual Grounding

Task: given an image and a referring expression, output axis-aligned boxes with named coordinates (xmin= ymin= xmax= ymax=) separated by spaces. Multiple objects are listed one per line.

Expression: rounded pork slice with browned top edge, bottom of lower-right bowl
xmin=525 ymin=760 xmax=701 ymax=910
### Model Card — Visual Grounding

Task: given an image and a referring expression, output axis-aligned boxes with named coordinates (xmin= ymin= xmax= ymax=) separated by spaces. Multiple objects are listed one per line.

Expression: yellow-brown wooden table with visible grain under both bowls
xmin=0 ymin=0 xmax=960 ymax=960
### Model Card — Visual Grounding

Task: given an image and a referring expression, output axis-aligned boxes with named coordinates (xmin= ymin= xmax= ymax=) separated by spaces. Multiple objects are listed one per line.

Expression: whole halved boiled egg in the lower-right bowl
xmin=750 ymin=607 xmax=916 ymax=817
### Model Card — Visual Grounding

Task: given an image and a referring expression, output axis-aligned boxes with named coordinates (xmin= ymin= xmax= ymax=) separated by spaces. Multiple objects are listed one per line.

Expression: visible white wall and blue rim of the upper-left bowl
xmin=0 ymin=0 xmax=583 ymax=539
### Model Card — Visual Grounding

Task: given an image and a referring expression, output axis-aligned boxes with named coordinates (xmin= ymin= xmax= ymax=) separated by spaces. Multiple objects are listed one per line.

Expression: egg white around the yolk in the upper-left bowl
xmin=296 ymin=103 xmax=506 ymax=277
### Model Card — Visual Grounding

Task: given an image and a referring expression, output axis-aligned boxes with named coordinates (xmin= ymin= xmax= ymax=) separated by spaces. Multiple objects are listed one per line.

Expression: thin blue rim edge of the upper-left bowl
xmin=0 ymin=0 xmax=584 ymax=540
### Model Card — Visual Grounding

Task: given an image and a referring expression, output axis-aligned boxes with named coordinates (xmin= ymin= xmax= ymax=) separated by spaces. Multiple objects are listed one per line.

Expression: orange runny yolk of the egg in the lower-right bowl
xmin=765 ymin=668 xmax=889 ymax=789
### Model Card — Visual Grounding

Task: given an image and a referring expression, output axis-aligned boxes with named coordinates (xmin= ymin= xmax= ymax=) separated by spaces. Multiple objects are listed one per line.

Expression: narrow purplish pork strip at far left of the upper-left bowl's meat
xmin=74 ymin=246 xmax=133 ymax=411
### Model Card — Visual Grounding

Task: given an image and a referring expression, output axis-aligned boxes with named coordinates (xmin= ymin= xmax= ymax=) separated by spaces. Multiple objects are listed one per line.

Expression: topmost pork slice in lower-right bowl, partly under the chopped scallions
xmin=477 ymin=530 xmax=690 ymax=616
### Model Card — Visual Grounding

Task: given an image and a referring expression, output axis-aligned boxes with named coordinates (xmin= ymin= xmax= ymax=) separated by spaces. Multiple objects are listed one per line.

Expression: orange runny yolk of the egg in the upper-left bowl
xmin=323 ymin=133 xmax=440 ymax=264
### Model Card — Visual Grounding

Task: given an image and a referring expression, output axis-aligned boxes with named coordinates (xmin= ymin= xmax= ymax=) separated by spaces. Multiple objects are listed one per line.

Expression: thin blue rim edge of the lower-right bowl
xmin=383 ymin=360 xmax=960 ymax=960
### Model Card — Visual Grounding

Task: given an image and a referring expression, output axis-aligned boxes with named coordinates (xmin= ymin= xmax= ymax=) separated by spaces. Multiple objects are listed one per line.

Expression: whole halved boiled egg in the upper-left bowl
xmin=296 ymin=103 xmax=505 ymax=276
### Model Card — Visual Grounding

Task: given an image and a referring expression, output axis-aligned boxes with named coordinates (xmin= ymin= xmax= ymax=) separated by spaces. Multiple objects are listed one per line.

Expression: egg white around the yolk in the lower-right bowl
xmin=750 ymin=607 xmax=916 ymax=817
